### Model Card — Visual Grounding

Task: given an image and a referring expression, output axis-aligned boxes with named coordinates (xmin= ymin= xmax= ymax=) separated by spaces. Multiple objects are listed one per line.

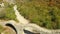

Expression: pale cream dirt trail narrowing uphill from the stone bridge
xmin=13 ymin=5 xmax=29 ymax=24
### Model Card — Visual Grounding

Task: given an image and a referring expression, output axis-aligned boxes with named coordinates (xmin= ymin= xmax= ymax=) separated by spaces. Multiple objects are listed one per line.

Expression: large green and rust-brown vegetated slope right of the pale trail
xmin=16 ymin=0 xmax=60 ymax=29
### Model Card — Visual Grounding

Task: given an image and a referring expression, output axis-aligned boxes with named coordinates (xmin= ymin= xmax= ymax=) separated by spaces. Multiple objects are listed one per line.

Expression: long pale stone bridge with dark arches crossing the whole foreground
xmin=0 ymin=20 xmax=60 ymax=34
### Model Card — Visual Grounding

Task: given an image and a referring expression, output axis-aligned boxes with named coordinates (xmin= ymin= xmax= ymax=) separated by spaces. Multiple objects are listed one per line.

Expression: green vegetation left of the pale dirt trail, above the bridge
xmin=0 ymin=2 xmax=17 ymax=20
